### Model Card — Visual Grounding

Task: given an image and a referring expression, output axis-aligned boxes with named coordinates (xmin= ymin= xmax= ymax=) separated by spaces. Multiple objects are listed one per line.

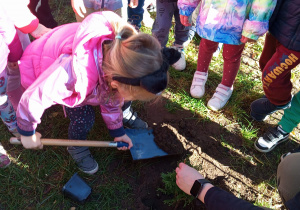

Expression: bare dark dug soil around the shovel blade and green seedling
xmin=112 ymin=95 xmax=294 ymax=210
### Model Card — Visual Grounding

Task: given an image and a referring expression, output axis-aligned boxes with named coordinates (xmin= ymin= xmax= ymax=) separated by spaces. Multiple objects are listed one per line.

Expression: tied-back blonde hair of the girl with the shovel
xmin=102 ymin=21 xmax=163 ymax=100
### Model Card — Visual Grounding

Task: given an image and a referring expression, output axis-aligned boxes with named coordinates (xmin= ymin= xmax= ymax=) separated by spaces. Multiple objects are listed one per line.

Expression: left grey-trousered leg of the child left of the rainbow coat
xmin=152 ymin=0 xmax=174 ymax=47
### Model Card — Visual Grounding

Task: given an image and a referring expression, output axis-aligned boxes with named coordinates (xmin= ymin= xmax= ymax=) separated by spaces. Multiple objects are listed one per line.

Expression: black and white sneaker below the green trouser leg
xmin=254 ymin=126 xmax=289 ymax=152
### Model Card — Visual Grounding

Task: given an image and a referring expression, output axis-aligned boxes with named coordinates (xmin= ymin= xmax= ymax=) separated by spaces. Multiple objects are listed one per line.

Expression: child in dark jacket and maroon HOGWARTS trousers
xmin=250 ymin=0 xmax=300 ymax=121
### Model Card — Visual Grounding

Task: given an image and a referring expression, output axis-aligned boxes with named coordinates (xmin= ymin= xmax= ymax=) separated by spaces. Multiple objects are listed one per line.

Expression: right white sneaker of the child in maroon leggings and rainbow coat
xmin=207 ymin=84 xmax=233 ymax=111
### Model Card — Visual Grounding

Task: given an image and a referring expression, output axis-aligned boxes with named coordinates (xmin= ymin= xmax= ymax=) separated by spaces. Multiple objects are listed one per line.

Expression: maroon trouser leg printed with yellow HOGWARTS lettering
xmin=262 ymin=45 xmax=300 ymax=106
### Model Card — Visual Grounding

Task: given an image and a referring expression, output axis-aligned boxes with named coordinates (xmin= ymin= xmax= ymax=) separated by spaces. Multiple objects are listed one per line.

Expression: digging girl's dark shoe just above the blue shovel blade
xmin=123 ymin=106 xmax=148 ymax=129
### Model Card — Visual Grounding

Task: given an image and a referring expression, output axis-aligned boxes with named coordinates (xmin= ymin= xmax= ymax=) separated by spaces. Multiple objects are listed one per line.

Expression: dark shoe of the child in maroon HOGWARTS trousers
xmin=250 ymin=97 xmax=291 ymax=122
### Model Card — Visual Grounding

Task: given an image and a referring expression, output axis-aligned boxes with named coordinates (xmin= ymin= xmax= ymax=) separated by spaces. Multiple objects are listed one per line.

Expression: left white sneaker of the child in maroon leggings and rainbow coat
xmin=190 ymin=71 xmax=208 ymax=98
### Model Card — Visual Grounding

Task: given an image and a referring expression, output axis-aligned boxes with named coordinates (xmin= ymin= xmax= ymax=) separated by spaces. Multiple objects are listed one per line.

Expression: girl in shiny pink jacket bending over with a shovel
xmin=17 ymin=11 xmax=180 ymax=174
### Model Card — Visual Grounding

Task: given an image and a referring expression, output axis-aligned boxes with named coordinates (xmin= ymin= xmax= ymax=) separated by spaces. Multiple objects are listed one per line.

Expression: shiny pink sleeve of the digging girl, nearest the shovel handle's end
xmin=17 ymin=55 xmax=74 ymax=136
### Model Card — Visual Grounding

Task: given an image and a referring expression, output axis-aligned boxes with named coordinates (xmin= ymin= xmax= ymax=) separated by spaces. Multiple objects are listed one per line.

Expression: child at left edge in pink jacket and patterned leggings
xmin=0 ymin=0 xmax=48 ymax=168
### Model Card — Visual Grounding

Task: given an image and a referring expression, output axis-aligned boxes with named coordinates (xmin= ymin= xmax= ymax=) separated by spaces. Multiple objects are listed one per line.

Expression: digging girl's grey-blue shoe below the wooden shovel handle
xmin=67 ymin=147 xmax=99 ymax=174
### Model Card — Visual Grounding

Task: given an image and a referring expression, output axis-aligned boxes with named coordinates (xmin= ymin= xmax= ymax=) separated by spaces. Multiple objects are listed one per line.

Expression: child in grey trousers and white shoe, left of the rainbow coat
xmin=152 ymin=0 xmax=190 ymax=71
